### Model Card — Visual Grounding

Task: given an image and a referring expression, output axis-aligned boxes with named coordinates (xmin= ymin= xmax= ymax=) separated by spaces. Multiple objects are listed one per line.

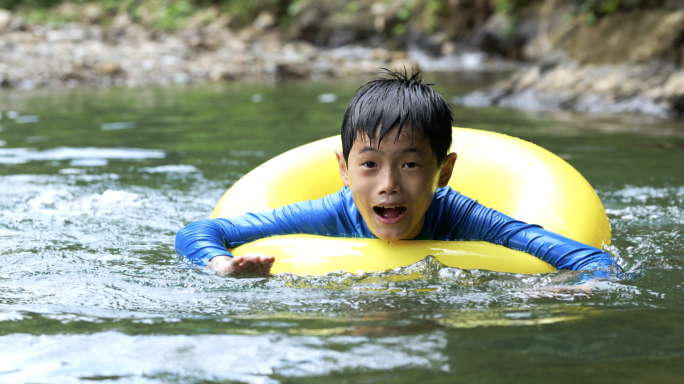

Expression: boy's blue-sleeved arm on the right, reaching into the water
xmin=436 ymin=190 xmax=617 ymax=271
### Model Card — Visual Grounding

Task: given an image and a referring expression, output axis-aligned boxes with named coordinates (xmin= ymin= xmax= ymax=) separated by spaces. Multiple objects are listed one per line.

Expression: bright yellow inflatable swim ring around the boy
xmin=211 ymin=128 xmax=610 ymax=275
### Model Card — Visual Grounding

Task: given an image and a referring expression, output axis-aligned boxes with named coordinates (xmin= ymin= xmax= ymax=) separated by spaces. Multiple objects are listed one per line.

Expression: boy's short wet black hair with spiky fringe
xmin=342 ymin=68 xmax=454 ymax=164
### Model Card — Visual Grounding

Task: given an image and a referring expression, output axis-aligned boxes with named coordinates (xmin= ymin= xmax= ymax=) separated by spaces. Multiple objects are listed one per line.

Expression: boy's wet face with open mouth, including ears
xmin=336 ymin=127 xmax=456 ymax=241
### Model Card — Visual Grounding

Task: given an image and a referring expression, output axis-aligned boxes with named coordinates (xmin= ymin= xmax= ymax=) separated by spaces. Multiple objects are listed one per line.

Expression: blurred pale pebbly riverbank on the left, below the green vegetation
xmin=0 ymin=4 xmax=515 ymax=89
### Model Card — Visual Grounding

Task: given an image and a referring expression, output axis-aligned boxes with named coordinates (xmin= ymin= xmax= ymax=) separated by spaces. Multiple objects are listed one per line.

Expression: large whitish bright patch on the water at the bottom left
xmin=3 ymin=332 xmax=449 ymax=384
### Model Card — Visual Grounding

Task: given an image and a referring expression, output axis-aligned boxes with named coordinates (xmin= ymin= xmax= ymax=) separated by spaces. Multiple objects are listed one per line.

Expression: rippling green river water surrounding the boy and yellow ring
xmin=0 ymin=75 xmax=684 ymax=383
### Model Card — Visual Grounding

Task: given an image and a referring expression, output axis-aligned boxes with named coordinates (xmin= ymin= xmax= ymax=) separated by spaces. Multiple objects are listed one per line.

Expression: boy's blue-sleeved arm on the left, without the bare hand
xmin=176 ymin=191 xmax=355 ymax=265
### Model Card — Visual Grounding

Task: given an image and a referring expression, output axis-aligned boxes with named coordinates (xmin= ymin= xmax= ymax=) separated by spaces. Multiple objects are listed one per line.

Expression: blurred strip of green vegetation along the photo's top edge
xmin=0 ymin=0 xmax=659 ymax=39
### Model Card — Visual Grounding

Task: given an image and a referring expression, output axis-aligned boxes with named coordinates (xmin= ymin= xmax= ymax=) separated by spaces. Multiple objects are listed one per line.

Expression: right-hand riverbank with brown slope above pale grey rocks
xmin=452 ymin=5 xmax=684 ymax=117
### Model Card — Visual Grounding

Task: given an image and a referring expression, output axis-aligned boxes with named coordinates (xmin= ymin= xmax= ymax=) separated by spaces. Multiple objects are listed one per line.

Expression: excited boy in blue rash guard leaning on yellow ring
xmin=176 ymin=71 xmax=615 ymax=275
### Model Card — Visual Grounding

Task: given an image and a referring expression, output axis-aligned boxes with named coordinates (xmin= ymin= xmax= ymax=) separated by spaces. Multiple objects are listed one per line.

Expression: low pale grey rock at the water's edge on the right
xmin=452 ymin=53 xmax=684 ymax=117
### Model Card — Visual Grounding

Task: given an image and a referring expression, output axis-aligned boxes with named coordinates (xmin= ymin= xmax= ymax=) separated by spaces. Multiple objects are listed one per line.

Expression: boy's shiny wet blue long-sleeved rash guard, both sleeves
xmin=176 ymin=187 xmax=616 ymax=271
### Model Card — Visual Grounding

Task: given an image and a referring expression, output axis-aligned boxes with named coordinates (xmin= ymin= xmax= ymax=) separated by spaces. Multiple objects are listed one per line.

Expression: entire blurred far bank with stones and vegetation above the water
xmin=0 ymin=0 xmax=684 ymax=117
